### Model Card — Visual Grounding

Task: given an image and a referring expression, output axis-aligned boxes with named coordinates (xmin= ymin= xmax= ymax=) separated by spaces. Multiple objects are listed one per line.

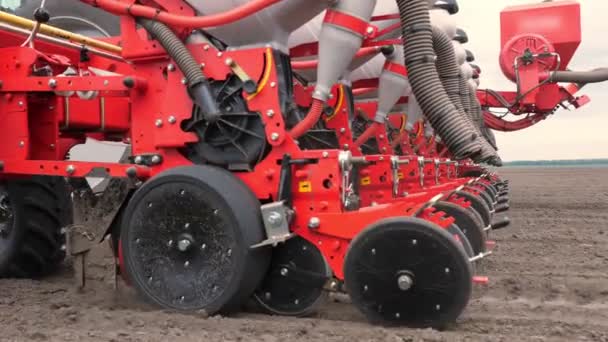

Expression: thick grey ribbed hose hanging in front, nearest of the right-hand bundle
xmin=397 ymin=0 xmax=481 ymax=159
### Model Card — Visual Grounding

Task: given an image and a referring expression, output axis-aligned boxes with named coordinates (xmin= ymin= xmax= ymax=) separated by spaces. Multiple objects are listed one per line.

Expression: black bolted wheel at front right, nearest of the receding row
xmin=344 ymin=218 xmax=472 ymax=329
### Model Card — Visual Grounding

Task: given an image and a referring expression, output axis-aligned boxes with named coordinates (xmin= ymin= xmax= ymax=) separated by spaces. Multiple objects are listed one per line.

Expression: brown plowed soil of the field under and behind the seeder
xmin=0 ymin=168 xmax=608 ymax=342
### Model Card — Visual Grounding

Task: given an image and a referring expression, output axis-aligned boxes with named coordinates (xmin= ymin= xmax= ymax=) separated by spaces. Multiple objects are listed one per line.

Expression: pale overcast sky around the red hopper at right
xmin=457 ymin=0 xmax=608 ymax=161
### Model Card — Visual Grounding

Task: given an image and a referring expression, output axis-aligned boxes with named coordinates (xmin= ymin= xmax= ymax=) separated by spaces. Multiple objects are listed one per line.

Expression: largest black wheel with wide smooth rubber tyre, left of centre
xmin=121 ymin=166 xmax=270 ymax=315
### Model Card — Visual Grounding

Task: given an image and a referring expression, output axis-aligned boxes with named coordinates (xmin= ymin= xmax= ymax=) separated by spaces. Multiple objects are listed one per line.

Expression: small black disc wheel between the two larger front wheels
xmin=253 ymin=237 xmax=331 ymax=317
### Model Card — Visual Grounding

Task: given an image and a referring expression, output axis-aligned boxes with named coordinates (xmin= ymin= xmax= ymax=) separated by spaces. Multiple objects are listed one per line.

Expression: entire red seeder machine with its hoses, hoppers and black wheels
xmin=0 ymin=0 xmax=607 ymax=327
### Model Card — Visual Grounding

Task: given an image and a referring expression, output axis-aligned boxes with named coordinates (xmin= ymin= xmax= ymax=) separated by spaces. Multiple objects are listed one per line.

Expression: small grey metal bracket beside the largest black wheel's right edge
xmin=250 ymin=201 xmax=295 ymax=249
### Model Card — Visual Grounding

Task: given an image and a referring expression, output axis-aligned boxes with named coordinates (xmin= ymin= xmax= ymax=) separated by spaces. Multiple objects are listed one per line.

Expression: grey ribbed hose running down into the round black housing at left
xmin=137 ymin=18 xmax=221 ymax=121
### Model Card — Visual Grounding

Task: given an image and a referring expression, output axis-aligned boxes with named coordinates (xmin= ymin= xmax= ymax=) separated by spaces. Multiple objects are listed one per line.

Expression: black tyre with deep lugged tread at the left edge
xmin=0 ymin=176 xmax=73 ymax=278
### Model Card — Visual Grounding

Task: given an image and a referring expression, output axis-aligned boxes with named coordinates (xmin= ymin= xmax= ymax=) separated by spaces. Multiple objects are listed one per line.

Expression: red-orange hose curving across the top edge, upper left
xmin=81 ymin=0 xmax=282 ymax=28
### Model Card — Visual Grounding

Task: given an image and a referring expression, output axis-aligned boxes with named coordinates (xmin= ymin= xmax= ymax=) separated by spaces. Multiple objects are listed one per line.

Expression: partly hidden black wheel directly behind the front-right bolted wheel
xmin=434 ymin=201 xmax=486 ymax=255
